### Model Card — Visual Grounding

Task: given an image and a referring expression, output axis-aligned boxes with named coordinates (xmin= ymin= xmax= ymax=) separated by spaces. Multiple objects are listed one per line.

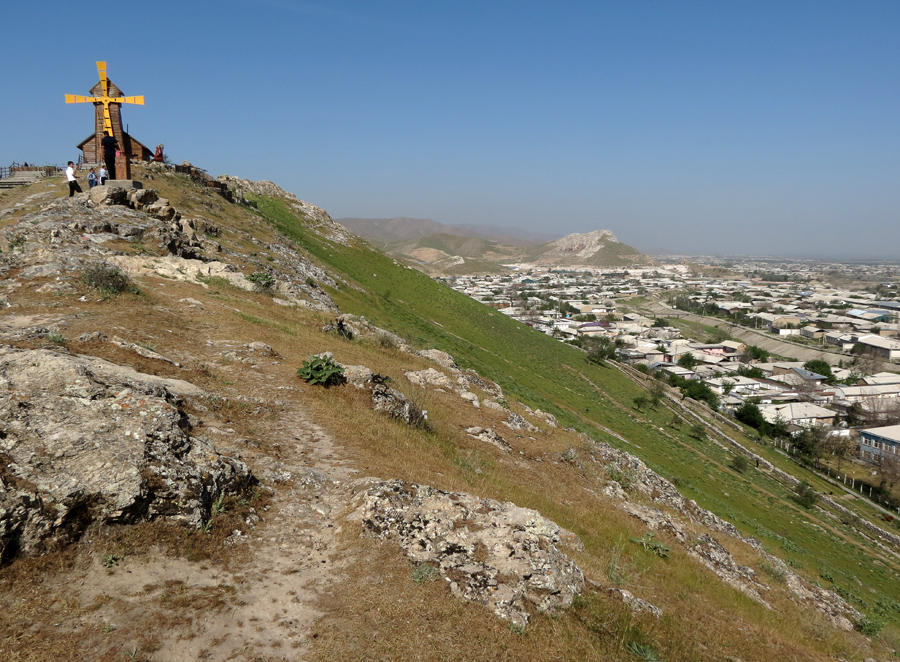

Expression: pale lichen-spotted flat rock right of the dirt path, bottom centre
xmin=358 ymin=480 xmax=584 ymax=627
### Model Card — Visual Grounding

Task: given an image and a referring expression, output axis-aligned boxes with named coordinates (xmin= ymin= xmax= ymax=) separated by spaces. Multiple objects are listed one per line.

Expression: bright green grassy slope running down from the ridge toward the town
xmin=251 ymin=193 xmax=900 ymax=648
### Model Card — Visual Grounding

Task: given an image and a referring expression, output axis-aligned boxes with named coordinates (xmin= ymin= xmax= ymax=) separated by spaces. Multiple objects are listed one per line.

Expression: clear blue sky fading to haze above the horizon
xmin=0 ymin=0 xmax=900 ymax=258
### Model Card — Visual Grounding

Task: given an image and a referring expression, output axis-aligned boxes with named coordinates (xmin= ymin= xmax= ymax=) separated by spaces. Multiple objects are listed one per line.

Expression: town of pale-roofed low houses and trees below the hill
xmin=444 ymin=258 xmax=900 ymax=504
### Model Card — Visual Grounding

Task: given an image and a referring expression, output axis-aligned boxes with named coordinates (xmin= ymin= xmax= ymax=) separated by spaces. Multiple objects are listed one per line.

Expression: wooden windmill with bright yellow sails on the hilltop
xmin=66 ymin=62 xmax=153 ymax=179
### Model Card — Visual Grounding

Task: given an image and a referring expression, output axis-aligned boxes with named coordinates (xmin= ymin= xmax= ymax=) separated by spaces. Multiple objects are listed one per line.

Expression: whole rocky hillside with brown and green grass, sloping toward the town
xmin=0 ymin=167 xmax=900 ymax=662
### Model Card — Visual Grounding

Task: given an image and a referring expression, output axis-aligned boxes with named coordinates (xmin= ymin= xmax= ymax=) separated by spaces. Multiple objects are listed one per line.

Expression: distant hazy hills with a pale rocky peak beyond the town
xmin=337 ymin=217 xmax=653 ymax=274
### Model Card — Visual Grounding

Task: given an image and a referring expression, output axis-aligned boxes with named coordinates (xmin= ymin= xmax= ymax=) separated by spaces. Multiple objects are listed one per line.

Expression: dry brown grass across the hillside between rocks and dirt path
xmin=0 ymin=169 xmax=888 ymax=662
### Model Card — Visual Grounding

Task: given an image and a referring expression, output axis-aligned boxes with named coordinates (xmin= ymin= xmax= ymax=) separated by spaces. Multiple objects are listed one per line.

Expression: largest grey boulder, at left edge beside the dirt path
xmin=0 ymin=347 xmax=252 ymax=560
